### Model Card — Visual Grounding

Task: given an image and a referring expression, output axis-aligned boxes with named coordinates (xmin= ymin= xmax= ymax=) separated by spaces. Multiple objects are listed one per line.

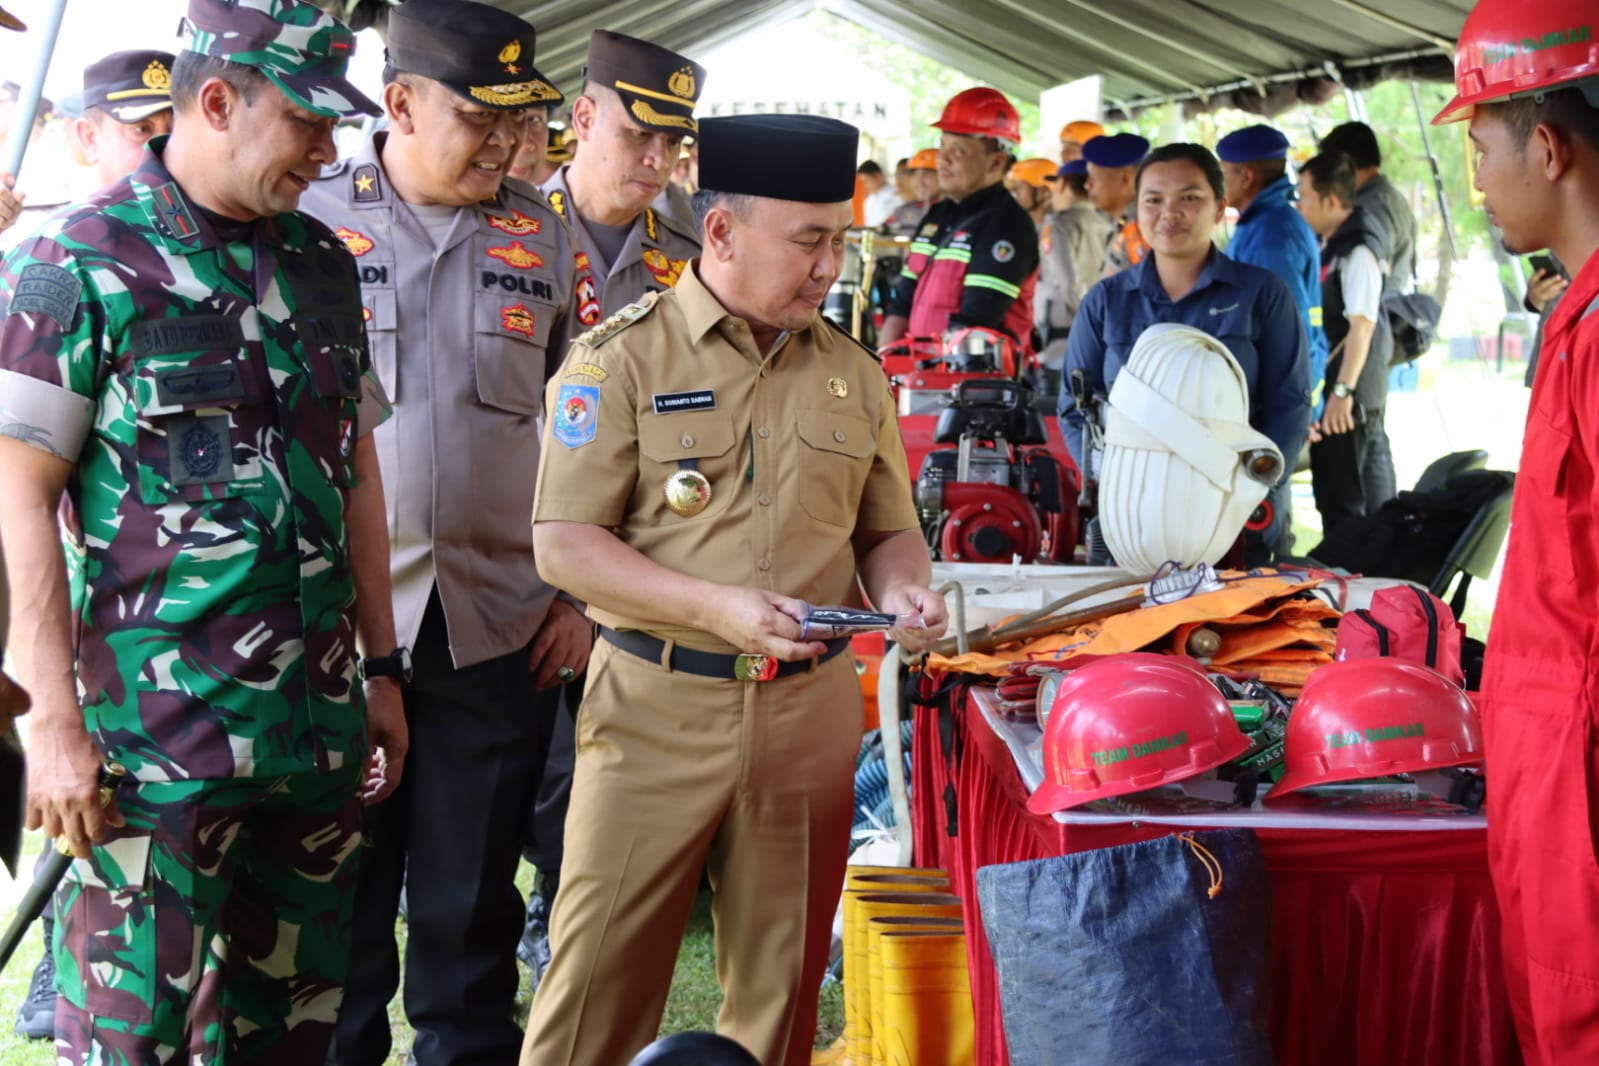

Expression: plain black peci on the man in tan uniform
xmin=699 ymin=115 xmax=860 ymax=203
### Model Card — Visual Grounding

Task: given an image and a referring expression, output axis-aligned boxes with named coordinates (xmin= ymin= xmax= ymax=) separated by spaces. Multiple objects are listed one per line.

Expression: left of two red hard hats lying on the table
xmin=1027 ymin=652 xmax=1249 ymax=815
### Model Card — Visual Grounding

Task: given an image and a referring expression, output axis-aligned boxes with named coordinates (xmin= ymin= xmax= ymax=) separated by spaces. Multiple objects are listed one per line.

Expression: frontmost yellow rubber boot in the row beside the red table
xmin=873 ymin=932 xmax=977 ymax=1066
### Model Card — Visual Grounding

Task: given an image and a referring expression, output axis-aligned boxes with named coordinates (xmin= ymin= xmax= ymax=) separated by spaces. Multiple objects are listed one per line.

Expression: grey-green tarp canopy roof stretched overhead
xmin=466 ymin=0 xmax=1473 ymax=113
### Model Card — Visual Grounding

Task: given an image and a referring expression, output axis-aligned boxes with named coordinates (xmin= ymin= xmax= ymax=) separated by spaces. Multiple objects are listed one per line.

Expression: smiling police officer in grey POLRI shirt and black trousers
xmin=304 ymin=0 xmax=598 ymax=1066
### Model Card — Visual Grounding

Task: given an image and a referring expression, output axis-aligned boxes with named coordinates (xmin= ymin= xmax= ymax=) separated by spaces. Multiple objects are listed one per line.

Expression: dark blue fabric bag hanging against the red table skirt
xmin=977 ymin=829 xmax=1276 ymax=1066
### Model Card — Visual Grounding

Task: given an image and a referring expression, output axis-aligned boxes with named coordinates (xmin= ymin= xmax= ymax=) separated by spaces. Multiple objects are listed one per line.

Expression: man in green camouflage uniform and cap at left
xmin=0 ymin=0 xmax=406 ymax=1063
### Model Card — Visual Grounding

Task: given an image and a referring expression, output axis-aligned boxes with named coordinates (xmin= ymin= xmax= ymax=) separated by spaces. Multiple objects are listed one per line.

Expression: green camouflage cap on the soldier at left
xmin=189 ymin=0 xmax=379 ymax=118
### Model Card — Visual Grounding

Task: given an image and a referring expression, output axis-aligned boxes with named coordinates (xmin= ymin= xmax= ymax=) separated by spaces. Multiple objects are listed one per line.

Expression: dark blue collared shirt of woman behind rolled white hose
xmin=1057 ymin=249 xmax=1310 ymax=470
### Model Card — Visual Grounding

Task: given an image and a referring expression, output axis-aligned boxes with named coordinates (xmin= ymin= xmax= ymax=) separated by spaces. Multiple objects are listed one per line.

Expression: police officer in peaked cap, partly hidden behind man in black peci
xmin=544 ymin=30 xmax=705 ymax=315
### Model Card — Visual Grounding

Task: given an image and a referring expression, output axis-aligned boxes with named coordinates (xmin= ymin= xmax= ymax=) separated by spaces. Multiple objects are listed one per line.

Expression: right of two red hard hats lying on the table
xmin=1266 ymin=658 xmax=1482 ymax=802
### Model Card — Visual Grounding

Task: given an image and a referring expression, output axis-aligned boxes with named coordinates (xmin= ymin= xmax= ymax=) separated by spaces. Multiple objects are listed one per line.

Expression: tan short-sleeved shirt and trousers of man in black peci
xmin=521 ymin=261 xmax=916 ymax=1066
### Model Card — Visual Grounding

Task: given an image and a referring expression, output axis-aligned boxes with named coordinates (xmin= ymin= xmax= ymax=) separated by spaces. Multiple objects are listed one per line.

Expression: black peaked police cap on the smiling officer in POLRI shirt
xmin=389 ymin=0 xmax=563 ymax=110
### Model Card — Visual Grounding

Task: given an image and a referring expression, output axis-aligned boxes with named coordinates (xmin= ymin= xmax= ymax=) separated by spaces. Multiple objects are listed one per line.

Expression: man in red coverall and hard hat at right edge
xmin=1433 ymin=0 xmax=1599 ymax=1066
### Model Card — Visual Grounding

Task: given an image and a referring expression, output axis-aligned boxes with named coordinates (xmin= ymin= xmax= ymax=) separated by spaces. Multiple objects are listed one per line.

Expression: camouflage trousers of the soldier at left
xmin=54 ymin=764 xmax=361 ymax=1066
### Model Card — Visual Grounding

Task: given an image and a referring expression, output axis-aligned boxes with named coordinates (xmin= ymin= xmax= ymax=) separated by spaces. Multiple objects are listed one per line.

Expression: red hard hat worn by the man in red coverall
xmin=1433 ymin=0 xmax=1599 ymax=125
